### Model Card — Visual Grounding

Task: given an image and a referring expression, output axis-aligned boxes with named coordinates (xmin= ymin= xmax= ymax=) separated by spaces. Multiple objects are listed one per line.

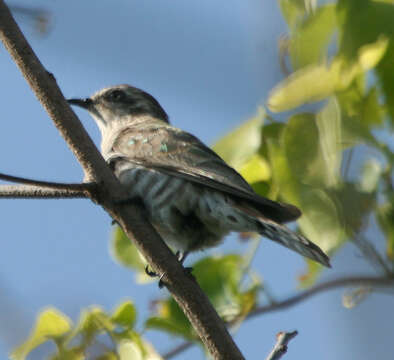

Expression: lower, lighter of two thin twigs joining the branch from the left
xmin=0 ymin=185 xmax=88 ymax=199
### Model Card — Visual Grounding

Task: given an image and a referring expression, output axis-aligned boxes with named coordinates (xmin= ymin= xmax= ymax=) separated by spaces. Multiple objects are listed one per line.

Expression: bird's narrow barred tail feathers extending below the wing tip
xmin=259 ymin=218 xmax=331 ymax=267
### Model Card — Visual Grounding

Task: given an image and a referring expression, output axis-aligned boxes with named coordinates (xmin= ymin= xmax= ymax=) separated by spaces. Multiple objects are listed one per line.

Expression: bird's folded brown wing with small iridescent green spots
xmin=107 ymin=124 xmax=301 ymax=223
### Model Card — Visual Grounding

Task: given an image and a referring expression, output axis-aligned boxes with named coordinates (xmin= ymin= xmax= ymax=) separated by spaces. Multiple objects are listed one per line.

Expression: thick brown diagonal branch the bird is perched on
xmin=0 ymin=0 xmax=244 ymax=359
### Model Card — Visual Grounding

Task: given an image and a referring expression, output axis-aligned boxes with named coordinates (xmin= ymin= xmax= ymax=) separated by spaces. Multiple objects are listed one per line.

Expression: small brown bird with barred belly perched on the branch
xmin=68 ymin=85 xmax=330 ymax=266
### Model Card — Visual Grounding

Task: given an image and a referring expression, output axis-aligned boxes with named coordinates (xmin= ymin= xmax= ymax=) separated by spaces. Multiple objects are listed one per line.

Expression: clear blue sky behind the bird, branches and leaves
xmin=0 ymin=0 xmax=394 ymax=360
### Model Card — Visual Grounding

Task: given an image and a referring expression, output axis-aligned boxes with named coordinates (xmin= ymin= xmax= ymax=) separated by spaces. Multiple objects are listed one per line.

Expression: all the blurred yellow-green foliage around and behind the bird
xmin=12 ymin=0 xmax=394 ymax=359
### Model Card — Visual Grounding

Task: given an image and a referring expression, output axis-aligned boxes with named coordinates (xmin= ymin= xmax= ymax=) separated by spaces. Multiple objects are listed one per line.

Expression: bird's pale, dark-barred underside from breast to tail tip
xmin=116 ymin=162 xmax=330 ymax=266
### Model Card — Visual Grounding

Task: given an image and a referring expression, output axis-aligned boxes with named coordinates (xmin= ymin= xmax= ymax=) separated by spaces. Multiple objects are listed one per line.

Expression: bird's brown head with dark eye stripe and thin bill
xmin=67 ymin=85 xmax=169 ymax=129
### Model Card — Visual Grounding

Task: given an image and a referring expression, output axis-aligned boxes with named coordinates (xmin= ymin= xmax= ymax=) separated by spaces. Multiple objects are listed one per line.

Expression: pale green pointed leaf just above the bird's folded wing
xmin=212 ymin=108 xmax=265 ymax=169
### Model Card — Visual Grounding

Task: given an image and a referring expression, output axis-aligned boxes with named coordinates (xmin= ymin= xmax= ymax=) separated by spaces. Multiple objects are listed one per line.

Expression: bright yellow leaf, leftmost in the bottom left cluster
xmin=10 ymin=308 xmax=71 ymax=360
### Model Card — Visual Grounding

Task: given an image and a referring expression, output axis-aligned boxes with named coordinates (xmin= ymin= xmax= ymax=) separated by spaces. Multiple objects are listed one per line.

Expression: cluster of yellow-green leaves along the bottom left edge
xmin=10 ymin=301 xmax=161 ymax=360
